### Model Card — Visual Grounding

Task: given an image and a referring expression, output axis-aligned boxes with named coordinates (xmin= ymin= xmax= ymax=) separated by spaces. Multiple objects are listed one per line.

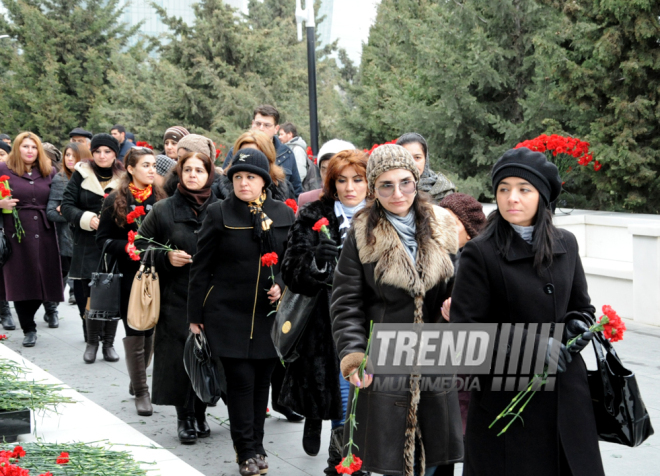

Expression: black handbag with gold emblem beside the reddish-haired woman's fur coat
xmin=270 ymin=287 xmax=319 ymax=362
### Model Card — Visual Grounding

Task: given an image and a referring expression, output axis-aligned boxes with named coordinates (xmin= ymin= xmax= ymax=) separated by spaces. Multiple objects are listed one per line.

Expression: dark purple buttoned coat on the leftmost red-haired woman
xmin=0 ymin=163 xmax=64 ymax=302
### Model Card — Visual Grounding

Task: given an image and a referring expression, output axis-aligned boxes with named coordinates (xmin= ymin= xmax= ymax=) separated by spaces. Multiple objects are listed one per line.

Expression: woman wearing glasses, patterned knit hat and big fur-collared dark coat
xmin=330 ymin=145 xmax=463 ymax=476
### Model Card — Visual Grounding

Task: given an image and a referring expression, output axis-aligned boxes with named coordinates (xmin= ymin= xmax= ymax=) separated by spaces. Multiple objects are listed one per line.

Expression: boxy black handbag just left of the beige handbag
xmin=85 ymin=240 xmax=122 ymax=321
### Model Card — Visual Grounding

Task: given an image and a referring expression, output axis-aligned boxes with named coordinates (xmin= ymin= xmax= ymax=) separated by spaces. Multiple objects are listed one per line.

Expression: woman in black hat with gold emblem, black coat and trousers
xmin=188 ymin=149 xmax=294 ymax=476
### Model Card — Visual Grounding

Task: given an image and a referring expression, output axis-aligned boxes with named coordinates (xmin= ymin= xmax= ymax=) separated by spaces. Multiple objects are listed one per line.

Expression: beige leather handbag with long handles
xmin=127 ymin=248 xmax=160 ymax=331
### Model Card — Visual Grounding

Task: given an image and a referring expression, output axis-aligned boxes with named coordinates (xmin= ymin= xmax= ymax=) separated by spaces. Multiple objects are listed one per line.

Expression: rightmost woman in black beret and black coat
xmin=450 ymin=148 xmax=604 ymax=476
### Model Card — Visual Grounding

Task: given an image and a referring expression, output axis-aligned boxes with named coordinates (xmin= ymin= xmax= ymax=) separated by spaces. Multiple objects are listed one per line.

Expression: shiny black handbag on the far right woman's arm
xmin=587 ymin=332 xmax=653 ymax=447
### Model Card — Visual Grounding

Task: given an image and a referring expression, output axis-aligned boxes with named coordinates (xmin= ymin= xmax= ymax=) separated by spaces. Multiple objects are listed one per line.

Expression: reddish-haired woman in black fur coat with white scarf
xmin=279 ymin=150 xmax=369 ymax=474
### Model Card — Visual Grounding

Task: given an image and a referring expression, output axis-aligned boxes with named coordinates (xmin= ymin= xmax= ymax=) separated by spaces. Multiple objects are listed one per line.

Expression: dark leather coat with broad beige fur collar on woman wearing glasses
xmin=330 ymin=207 xmax=463 ymax=476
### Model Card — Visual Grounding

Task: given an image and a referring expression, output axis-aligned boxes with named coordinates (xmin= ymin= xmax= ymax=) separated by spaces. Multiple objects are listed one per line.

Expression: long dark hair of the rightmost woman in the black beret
xmin=479 ymin=197 xmax=558 ymax=276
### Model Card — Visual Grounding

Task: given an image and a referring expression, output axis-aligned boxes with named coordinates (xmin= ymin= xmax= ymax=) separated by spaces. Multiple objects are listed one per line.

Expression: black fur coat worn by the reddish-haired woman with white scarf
xmin=279 ymin=199 xmax=343 ymax=420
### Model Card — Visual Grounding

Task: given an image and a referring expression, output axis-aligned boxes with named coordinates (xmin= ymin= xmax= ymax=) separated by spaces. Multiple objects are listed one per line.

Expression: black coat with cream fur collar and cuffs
xmin=60 ymin=162 xmax=121 ymax=279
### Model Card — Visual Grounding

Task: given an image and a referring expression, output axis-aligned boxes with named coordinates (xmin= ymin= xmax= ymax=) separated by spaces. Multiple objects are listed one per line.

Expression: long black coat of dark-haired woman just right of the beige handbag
xmin=137 ymin=190 xmax=217 ymax=406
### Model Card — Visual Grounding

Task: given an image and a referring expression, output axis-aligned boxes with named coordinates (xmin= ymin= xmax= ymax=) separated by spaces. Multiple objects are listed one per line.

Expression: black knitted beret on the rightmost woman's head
xmin=491 ymin=147 xmax=561 ymax=204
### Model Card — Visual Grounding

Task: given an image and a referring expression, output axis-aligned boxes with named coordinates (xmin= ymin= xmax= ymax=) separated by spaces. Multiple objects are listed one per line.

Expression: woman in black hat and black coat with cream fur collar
xmin=60 ymin=134 xmax=124 ymax=356
